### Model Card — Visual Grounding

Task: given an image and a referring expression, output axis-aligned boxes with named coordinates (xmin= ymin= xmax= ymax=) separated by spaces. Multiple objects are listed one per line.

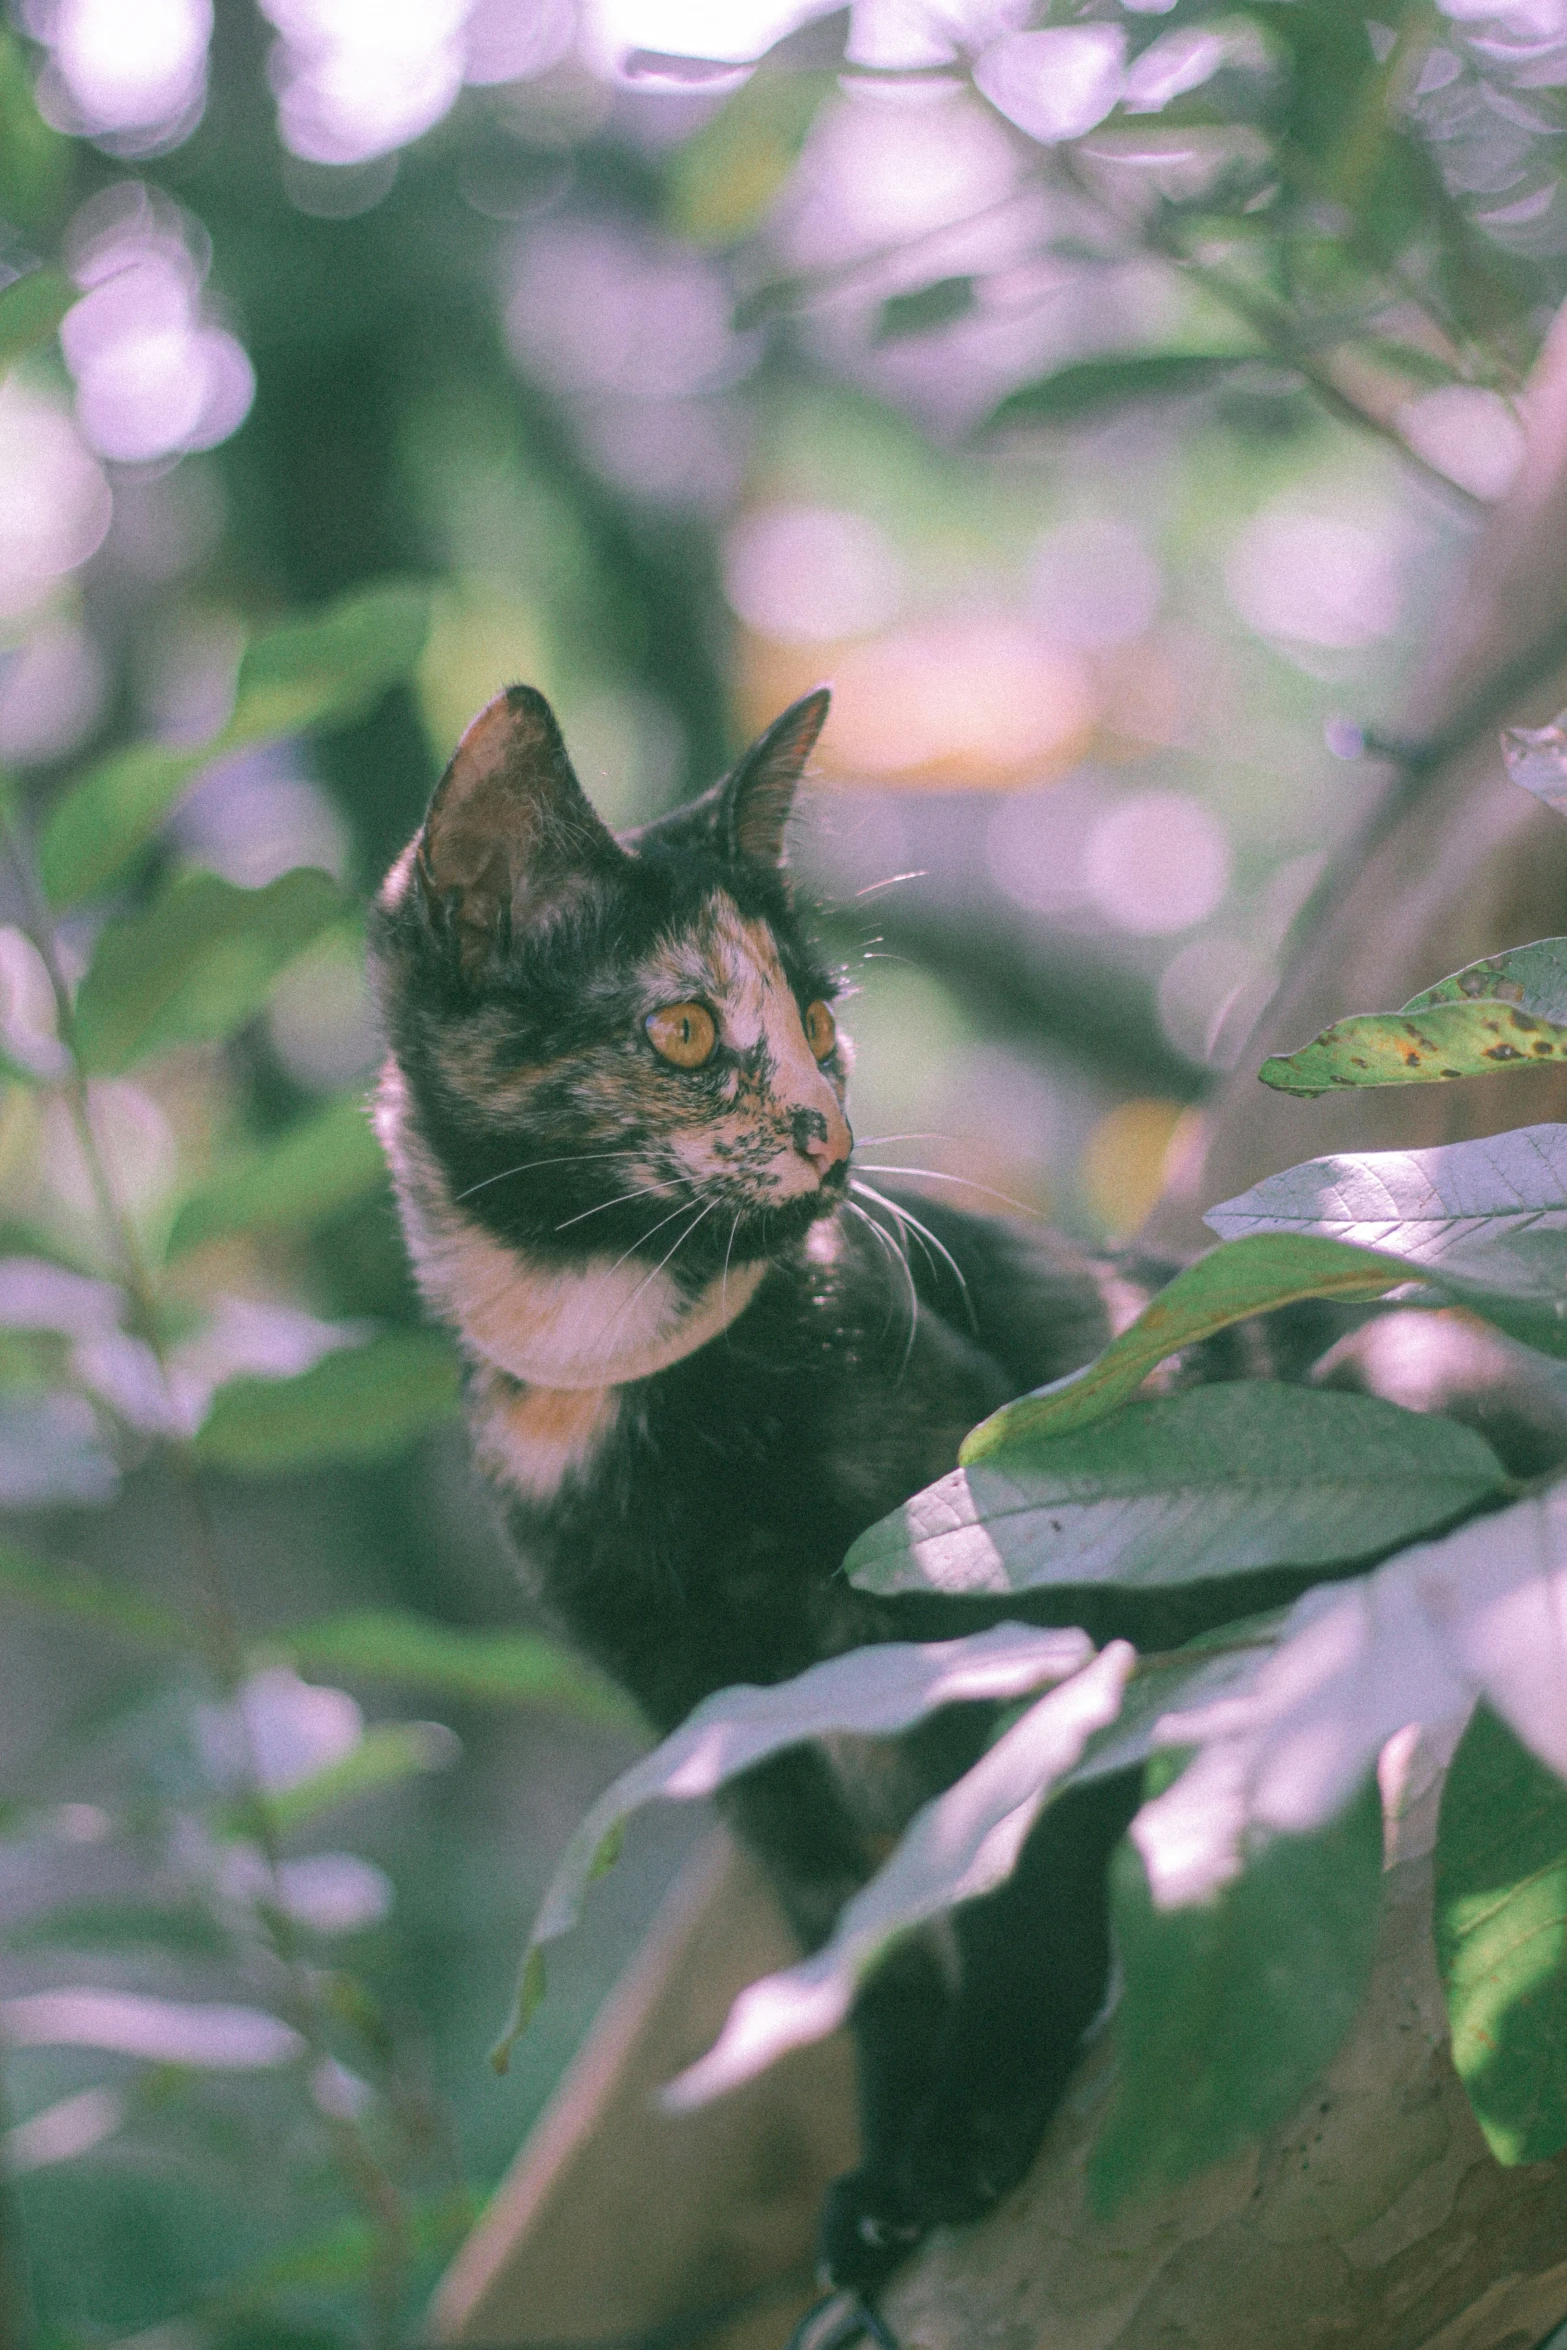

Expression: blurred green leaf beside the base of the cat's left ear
xmin=73 ymin=865 xmax=343 ymax=1074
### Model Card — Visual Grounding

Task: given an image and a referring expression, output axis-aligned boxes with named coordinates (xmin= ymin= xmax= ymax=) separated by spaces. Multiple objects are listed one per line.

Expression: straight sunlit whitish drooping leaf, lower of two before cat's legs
xmin=663 ymin=1640 xmax=1135 ymax=2113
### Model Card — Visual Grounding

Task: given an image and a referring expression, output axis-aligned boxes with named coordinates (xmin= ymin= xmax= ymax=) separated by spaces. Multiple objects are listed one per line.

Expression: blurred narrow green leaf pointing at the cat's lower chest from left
xmin=276 ymin=1610 xmax=641 ymax=1730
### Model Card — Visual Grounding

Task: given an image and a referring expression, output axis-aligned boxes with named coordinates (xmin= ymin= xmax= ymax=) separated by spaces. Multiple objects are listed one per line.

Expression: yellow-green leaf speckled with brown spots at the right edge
xmin=1257 ymin=996 xmax=1567 ymax=1097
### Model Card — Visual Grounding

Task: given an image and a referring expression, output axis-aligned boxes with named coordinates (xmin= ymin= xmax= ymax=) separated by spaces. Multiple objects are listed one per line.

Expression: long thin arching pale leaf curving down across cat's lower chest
xmin=491 ymin=1624 xmax=1092 ymax=2073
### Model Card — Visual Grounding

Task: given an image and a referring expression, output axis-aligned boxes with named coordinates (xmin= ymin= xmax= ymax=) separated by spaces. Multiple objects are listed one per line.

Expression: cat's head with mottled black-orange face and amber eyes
xmin=374 ymin=686 xmax=853 ymax=1290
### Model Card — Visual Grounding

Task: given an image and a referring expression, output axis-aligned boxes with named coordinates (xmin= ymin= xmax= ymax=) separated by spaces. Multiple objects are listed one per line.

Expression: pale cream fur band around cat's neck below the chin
xmin=376 ymin=1069 xmax=768 ymax=1391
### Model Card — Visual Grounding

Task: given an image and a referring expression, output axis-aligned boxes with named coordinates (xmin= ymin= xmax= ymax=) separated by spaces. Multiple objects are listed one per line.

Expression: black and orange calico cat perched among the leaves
xmin=374 ymin=686 xmax=1323 ymax=2291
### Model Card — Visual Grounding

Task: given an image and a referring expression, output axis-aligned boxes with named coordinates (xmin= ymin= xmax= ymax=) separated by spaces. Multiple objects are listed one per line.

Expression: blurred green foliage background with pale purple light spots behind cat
xmin=0 ymin=0 xmax=1567 ymax=2345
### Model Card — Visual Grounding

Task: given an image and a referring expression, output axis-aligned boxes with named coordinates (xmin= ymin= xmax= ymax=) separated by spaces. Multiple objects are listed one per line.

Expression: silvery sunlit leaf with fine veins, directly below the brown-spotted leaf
xmin=1203 ymin=1126 xmax=1567 ymax=1269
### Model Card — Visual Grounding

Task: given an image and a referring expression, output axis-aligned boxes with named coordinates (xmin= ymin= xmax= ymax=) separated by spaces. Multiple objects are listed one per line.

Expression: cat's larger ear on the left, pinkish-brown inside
xmin=416 ymin=686 xmax=620 ymax=978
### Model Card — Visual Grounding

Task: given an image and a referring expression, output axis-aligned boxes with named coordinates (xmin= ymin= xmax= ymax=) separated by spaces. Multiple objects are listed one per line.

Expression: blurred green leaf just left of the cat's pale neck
xmin=195 ymin=1330 xmax=458 ymax=1476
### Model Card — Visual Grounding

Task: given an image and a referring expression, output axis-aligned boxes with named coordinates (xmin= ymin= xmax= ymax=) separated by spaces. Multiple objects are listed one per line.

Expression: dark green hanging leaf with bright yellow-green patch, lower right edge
xmin=1435 ymin=1706 xmax=1567 ymax=2162
